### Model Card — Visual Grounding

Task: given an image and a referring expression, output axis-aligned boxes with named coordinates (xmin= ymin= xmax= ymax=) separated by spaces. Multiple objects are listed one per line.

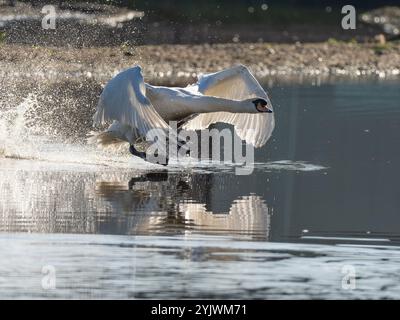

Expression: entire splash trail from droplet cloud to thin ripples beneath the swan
xmin=0 ymin=91 xmax=326 ymax=173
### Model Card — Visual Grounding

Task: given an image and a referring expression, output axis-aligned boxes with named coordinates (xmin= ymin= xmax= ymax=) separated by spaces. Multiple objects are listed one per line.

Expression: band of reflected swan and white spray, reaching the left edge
xmin=0 ymin=167 xmax=272 ymax=240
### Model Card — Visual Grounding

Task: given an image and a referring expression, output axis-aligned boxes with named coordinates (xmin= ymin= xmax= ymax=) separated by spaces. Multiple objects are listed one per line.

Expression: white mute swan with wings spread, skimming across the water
xmin=91 ymin=65 xmax=275 ymax=165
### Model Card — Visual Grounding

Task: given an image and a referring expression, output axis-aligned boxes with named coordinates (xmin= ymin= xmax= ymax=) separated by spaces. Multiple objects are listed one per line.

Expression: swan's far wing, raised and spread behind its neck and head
xmin=182 ymin=65 xmax=275 ymax=148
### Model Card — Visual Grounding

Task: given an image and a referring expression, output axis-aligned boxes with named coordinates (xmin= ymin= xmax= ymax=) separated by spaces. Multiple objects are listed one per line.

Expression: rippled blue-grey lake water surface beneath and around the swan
xmin=0 ymin=79 xmax=400 ymax=299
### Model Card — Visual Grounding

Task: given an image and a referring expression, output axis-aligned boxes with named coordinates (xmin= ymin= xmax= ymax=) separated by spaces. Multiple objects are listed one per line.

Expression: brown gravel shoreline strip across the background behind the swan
xmin=0 ymin=41 xmax=400 ymax=85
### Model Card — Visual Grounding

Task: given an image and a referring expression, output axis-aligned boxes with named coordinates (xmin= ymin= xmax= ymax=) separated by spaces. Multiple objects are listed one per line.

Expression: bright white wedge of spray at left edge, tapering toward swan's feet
xmin=0 ymin=94 xmax=149 ymax=170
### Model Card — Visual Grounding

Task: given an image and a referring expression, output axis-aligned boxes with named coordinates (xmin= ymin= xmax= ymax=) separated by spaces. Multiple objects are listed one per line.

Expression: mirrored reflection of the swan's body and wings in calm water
xmin=96 ymin=171 xmax=271 ymax=240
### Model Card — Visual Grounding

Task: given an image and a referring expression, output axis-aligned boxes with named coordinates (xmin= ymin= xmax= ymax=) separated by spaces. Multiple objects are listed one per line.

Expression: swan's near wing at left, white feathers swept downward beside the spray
xmin=93 ymin=66 xmax=169 ymax=149
